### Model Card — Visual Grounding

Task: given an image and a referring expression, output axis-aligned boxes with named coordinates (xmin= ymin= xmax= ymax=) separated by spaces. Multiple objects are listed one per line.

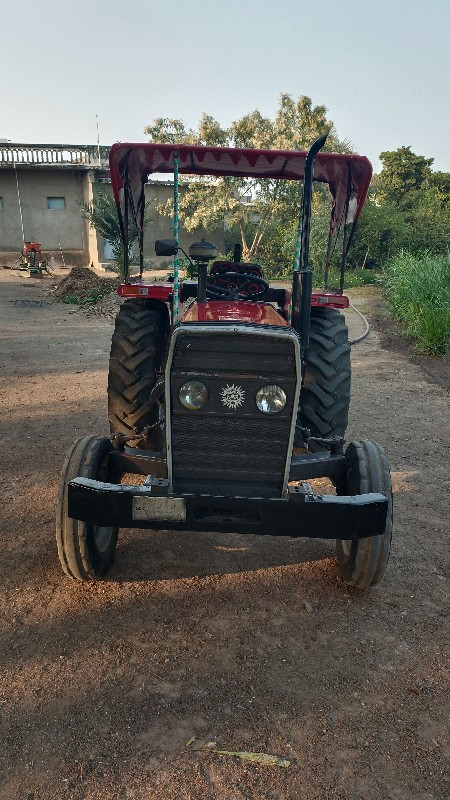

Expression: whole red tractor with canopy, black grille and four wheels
xmin=57 ymin=137 xmax=392 ymax=588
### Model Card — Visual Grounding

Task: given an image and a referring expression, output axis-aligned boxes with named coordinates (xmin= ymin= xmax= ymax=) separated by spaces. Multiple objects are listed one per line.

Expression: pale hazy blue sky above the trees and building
xmin=0 ymin=0 xmax=450 ymax=171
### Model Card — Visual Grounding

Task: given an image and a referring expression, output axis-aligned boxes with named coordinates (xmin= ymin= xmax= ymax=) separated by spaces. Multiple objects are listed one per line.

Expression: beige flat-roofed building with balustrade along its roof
xmin=0 ymin=140 xmax=224 ymax=267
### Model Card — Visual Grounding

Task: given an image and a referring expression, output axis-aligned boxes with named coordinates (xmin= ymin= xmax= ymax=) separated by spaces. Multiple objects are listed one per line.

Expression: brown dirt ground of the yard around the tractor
xmin=0 ymin=271 xmax=450 ymax=800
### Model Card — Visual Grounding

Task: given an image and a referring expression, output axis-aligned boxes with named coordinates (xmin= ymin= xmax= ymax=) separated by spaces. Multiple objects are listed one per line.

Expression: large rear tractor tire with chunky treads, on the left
xmin=108 ymin=300 xmax=169 ymax=449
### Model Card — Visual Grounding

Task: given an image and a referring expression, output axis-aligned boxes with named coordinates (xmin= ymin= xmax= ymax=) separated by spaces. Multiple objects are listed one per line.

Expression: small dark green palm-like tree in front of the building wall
xmin=81 ymin=189 xmax=154 ymax=278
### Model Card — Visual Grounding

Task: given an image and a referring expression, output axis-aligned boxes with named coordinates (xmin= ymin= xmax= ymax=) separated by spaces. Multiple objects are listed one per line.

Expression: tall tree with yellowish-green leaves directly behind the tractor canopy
xmin=145 ymin=94 xmax=351 ymax=260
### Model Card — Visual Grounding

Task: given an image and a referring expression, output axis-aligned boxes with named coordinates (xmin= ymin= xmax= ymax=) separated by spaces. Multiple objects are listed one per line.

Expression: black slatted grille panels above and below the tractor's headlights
xmin=171 ymin=332 xmax=296 ymax=497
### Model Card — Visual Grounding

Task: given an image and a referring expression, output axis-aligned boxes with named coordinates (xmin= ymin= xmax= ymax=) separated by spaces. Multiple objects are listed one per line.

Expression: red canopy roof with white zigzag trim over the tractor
xmin=109 ymin=142 xmax=372 ymax=233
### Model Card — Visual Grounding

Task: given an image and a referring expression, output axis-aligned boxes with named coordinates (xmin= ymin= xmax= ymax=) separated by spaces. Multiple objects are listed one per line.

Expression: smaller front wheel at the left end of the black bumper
xmin=56 ymin=436 xmax=119 ymax=581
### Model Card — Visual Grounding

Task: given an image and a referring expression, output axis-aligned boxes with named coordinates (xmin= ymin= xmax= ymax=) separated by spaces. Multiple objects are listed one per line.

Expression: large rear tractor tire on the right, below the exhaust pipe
xmin=296 ymin=308 xmax=351 ymax=450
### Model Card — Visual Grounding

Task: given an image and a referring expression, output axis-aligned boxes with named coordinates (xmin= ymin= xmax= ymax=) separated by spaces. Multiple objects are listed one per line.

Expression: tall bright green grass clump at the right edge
xmin=385 ymin=252 xmax=450 ymax=355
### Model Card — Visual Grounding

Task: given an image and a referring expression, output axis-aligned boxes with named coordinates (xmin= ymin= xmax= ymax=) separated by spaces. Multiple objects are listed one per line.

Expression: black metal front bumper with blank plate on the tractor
xmin=68 ymin=478 xmax=388 ymax=539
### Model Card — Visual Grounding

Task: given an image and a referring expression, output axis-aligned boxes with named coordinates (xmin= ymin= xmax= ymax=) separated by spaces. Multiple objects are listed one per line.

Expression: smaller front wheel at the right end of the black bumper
xmin=336 ymin=439 xmax=392 ymax=589
